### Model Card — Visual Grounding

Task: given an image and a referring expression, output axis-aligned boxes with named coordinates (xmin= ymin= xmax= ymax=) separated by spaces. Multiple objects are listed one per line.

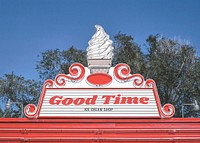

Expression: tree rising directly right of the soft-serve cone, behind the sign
xmin=113 ymin=33 xmax=145 ymax=74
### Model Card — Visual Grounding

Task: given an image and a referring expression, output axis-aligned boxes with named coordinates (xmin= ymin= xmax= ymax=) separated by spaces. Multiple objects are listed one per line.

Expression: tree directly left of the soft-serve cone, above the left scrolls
xmin=36 ymin=46 xmax=87 ymax=80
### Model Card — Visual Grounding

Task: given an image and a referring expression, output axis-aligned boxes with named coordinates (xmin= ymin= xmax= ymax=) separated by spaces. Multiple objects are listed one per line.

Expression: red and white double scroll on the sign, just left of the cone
xmin=55 ymin=63 xmax=85 ymax=86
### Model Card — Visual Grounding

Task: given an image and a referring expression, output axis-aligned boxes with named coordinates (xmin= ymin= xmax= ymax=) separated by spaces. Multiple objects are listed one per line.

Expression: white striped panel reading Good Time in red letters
xmin=40 ymin=89 xmax=159 ymax=117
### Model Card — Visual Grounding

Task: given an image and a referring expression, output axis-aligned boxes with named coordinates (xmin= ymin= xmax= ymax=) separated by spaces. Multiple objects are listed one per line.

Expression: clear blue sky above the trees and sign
xmin=0 ymin=0 xmax=200 ymax=79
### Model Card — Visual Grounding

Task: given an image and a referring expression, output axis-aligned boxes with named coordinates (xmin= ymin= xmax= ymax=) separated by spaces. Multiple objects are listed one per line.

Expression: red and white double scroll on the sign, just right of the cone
xmin=114 ymin=63 xmax=144 ymax=87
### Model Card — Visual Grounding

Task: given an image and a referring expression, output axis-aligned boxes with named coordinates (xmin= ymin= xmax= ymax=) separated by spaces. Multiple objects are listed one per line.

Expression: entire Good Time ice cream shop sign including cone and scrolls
xmin=24 ymin=25 xmax=175 ymax=118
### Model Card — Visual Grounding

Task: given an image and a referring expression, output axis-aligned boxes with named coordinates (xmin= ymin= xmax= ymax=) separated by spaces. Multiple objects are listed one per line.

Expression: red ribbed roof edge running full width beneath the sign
xmin=0 ymin=118 xmax=200 ymax=143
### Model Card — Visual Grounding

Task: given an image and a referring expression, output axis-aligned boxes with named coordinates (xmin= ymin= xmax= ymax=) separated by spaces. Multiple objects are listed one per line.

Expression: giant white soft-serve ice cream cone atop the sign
xmin=87 ymin=25 xmax=114 ymax=73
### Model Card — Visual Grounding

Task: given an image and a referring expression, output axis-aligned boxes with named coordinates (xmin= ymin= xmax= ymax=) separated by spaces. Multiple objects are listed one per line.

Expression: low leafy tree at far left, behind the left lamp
xmin=0 ymin=73 xmax=41 ymax=117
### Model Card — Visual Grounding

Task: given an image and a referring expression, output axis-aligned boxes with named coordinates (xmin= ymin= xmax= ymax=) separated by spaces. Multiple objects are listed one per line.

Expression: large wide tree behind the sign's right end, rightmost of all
xmin=146 ymin=35 xmax=200 ymax=116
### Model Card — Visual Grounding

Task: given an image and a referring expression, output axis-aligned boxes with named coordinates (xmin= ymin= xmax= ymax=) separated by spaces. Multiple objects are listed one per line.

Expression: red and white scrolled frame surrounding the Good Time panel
xmin=24 ymin=63 xmax=175 ymax=118
